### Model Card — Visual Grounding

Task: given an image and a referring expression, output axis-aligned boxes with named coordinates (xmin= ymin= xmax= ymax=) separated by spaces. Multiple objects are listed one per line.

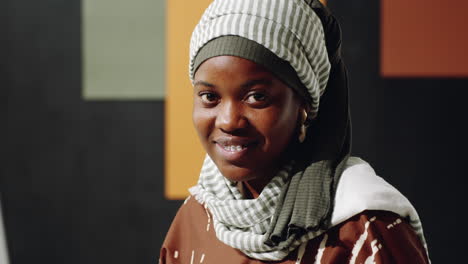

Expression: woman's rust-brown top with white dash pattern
xmin=160 ymin=197 xmax=429 ymax=264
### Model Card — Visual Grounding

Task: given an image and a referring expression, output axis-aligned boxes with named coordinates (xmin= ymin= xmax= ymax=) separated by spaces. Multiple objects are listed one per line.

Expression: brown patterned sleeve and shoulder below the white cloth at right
xmin=299 ymin=210 xmax=429 ymax=264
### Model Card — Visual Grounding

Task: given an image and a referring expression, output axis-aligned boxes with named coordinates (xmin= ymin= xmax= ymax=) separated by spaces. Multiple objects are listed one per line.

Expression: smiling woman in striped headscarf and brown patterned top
xmin=160 ymin=0 xmax=429 ymax=263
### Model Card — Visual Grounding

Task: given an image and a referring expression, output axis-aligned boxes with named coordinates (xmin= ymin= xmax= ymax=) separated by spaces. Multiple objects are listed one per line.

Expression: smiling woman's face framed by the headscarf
xmin=193 ymin=56 xmax=301 ymax=185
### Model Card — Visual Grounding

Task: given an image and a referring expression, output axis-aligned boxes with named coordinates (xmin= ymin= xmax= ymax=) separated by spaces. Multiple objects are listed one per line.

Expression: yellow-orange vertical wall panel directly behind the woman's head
xmin=164 ymin=0 xmax=211 ymax=199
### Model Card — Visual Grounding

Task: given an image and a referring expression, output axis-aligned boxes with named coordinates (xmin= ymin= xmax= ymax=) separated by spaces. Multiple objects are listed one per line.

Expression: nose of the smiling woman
xmin=216 ymin=102 xmax=248 ymax=133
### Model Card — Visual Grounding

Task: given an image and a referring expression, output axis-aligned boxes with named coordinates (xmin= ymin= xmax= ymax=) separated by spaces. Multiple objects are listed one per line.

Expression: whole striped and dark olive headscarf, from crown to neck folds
xmin=186 ymin=0 xmax=351 ymax=261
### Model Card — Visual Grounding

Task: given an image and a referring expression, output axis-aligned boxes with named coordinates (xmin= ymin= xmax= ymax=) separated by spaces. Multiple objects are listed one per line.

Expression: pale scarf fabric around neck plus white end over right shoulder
xmin=190 ymin=156 xmax=428 ymax=261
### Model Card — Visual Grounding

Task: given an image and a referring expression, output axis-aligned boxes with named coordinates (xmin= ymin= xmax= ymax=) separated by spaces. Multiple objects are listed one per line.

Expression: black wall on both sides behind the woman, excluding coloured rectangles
xmin=0 ymin=0 xmax=468 ymax=264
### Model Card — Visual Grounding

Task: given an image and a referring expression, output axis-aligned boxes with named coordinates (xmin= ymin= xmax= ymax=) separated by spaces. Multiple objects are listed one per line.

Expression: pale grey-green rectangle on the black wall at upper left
xmin=82 ymin=0 xmax=165 ymax=100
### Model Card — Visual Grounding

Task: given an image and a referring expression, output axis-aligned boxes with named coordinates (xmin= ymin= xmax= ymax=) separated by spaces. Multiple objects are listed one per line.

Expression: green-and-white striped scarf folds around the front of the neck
xmin=190 ymin=156 xmax=323 ymax=261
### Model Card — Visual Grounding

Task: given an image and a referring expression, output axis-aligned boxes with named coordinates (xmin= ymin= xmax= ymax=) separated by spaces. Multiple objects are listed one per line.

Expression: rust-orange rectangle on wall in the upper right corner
xmin=380 ymin=0 xmax=468 ymax=77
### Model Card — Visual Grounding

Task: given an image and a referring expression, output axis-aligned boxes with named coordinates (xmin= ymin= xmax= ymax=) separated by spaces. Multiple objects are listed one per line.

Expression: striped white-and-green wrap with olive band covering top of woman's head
xmin=189 ymin=0 xmax=330 ymax=117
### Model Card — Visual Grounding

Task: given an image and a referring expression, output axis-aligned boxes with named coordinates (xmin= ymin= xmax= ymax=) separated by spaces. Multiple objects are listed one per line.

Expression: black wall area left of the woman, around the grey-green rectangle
xmin=1 ymin=0 xmax=180 ymax=264
